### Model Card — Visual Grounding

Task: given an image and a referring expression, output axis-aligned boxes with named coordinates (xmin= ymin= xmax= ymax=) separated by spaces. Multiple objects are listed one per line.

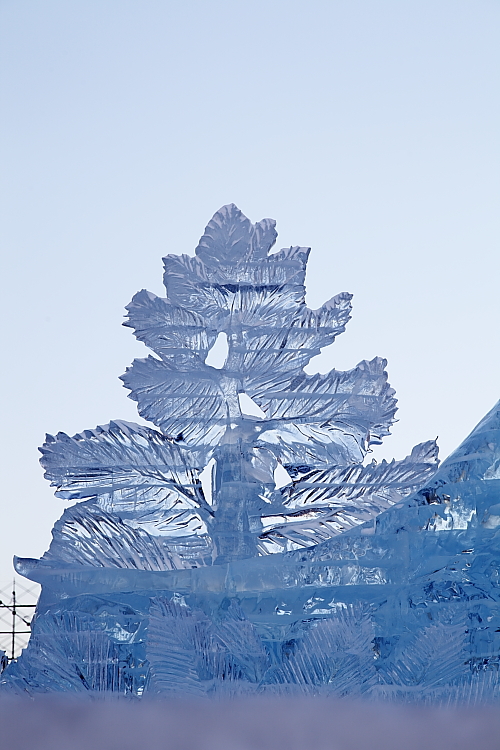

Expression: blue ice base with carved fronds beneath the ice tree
xmin=2 ymin=405 xmax=500 ymax=704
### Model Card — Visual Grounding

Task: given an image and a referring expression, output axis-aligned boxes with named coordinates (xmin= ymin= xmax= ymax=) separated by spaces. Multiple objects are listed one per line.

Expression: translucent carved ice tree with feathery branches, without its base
xmin=38 ymin=204 xmax=437 ymax=570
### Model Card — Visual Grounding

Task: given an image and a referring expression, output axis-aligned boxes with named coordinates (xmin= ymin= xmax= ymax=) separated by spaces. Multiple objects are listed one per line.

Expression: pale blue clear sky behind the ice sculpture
xmin=0 ymin=0 xmax=500 ymax=582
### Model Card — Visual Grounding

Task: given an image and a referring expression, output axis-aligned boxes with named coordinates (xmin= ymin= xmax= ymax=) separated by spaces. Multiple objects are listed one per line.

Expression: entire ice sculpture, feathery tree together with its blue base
xmin=1 ymin=205 xmax=500 ymax=702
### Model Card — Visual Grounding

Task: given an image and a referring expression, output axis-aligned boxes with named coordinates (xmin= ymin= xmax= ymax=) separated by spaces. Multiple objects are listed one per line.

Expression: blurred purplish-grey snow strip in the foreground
xmin=0 ymin=697 xmax=500 ymax=750
